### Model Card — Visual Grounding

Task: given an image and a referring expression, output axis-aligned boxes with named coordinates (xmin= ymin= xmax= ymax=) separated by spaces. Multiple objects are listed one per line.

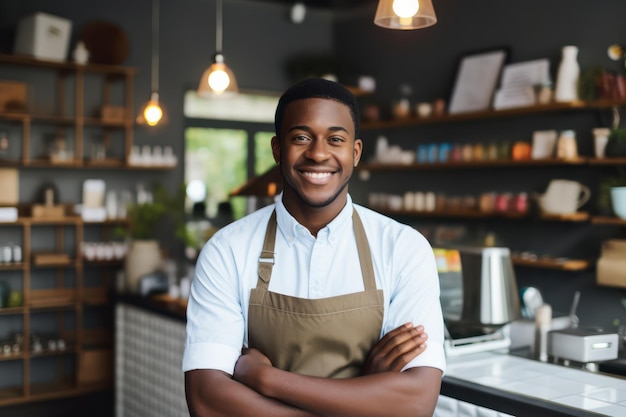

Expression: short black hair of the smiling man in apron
xmin=274 ymin=78 xmax=361 ymax=139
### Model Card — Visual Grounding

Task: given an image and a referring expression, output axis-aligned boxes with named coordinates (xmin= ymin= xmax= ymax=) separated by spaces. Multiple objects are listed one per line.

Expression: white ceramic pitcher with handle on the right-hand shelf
xmin=539 ymin=179 xmax=591 ymax=214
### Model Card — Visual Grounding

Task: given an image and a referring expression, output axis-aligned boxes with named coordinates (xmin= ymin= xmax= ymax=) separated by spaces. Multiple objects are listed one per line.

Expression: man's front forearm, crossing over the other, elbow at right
xmin=254 ymin=367 xmax=441 ymax=417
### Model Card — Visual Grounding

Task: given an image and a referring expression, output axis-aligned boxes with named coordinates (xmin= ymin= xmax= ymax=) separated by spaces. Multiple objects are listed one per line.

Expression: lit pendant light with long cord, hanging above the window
xmin=198 ymin=0 xmax=239 ymax=96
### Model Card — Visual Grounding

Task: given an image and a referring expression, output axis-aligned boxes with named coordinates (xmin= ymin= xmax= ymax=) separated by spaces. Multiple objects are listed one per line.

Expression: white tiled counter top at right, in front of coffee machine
xmin=446 ymin=351 xmax=626 ymax=417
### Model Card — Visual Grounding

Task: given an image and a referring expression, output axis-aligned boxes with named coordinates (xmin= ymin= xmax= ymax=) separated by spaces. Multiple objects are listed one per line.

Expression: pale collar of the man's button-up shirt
xmin=276 ymin=193 xmax=354 ymax=245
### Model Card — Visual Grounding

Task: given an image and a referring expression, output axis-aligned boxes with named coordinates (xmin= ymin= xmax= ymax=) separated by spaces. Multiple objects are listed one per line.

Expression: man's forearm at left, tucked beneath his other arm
xmin=185 ymin=369 xmax=319 ymax=417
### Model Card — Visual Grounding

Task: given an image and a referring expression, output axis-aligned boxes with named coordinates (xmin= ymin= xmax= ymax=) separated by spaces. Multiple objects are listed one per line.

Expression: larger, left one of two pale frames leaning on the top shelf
xmin=448 ymin=47 xmax=509 ymax=114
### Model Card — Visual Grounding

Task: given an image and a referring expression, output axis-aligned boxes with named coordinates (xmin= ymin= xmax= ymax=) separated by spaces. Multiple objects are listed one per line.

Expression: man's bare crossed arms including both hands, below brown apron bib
xmin=185 ymin=324 xmax=442 ymax=417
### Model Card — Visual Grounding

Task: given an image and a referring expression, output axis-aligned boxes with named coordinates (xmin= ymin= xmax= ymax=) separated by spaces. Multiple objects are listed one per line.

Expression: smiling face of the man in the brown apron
xmin=272 ymin=98 xmax=362 ymax=208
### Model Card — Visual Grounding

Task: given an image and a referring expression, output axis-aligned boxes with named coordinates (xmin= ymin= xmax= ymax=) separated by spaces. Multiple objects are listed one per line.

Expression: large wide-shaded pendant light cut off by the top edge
xmin=374 ymin=0 xmax=437 ymax=30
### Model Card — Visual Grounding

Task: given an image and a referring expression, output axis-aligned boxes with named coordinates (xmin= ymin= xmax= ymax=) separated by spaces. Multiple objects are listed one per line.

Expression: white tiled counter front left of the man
xmin=115 ymin=303 xmax=189 ymax=417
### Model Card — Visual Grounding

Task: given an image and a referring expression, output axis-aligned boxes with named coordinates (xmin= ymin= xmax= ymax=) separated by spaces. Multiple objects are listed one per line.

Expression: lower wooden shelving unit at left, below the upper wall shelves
xmin=0 ymin=216 xmax=118 ymax=407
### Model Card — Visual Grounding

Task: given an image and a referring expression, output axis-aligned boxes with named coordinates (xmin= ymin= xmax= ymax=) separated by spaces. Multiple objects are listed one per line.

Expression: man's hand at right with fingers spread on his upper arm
xmin=362 ymin=323 xmax=428 ymax=375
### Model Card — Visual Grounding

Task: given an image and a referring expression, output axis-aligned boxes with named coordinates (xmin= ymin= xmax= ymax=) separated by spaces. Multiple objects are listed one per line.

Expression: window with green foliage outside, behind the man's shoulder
xmin=184 ymin=91 xmax=278 ymax=219
